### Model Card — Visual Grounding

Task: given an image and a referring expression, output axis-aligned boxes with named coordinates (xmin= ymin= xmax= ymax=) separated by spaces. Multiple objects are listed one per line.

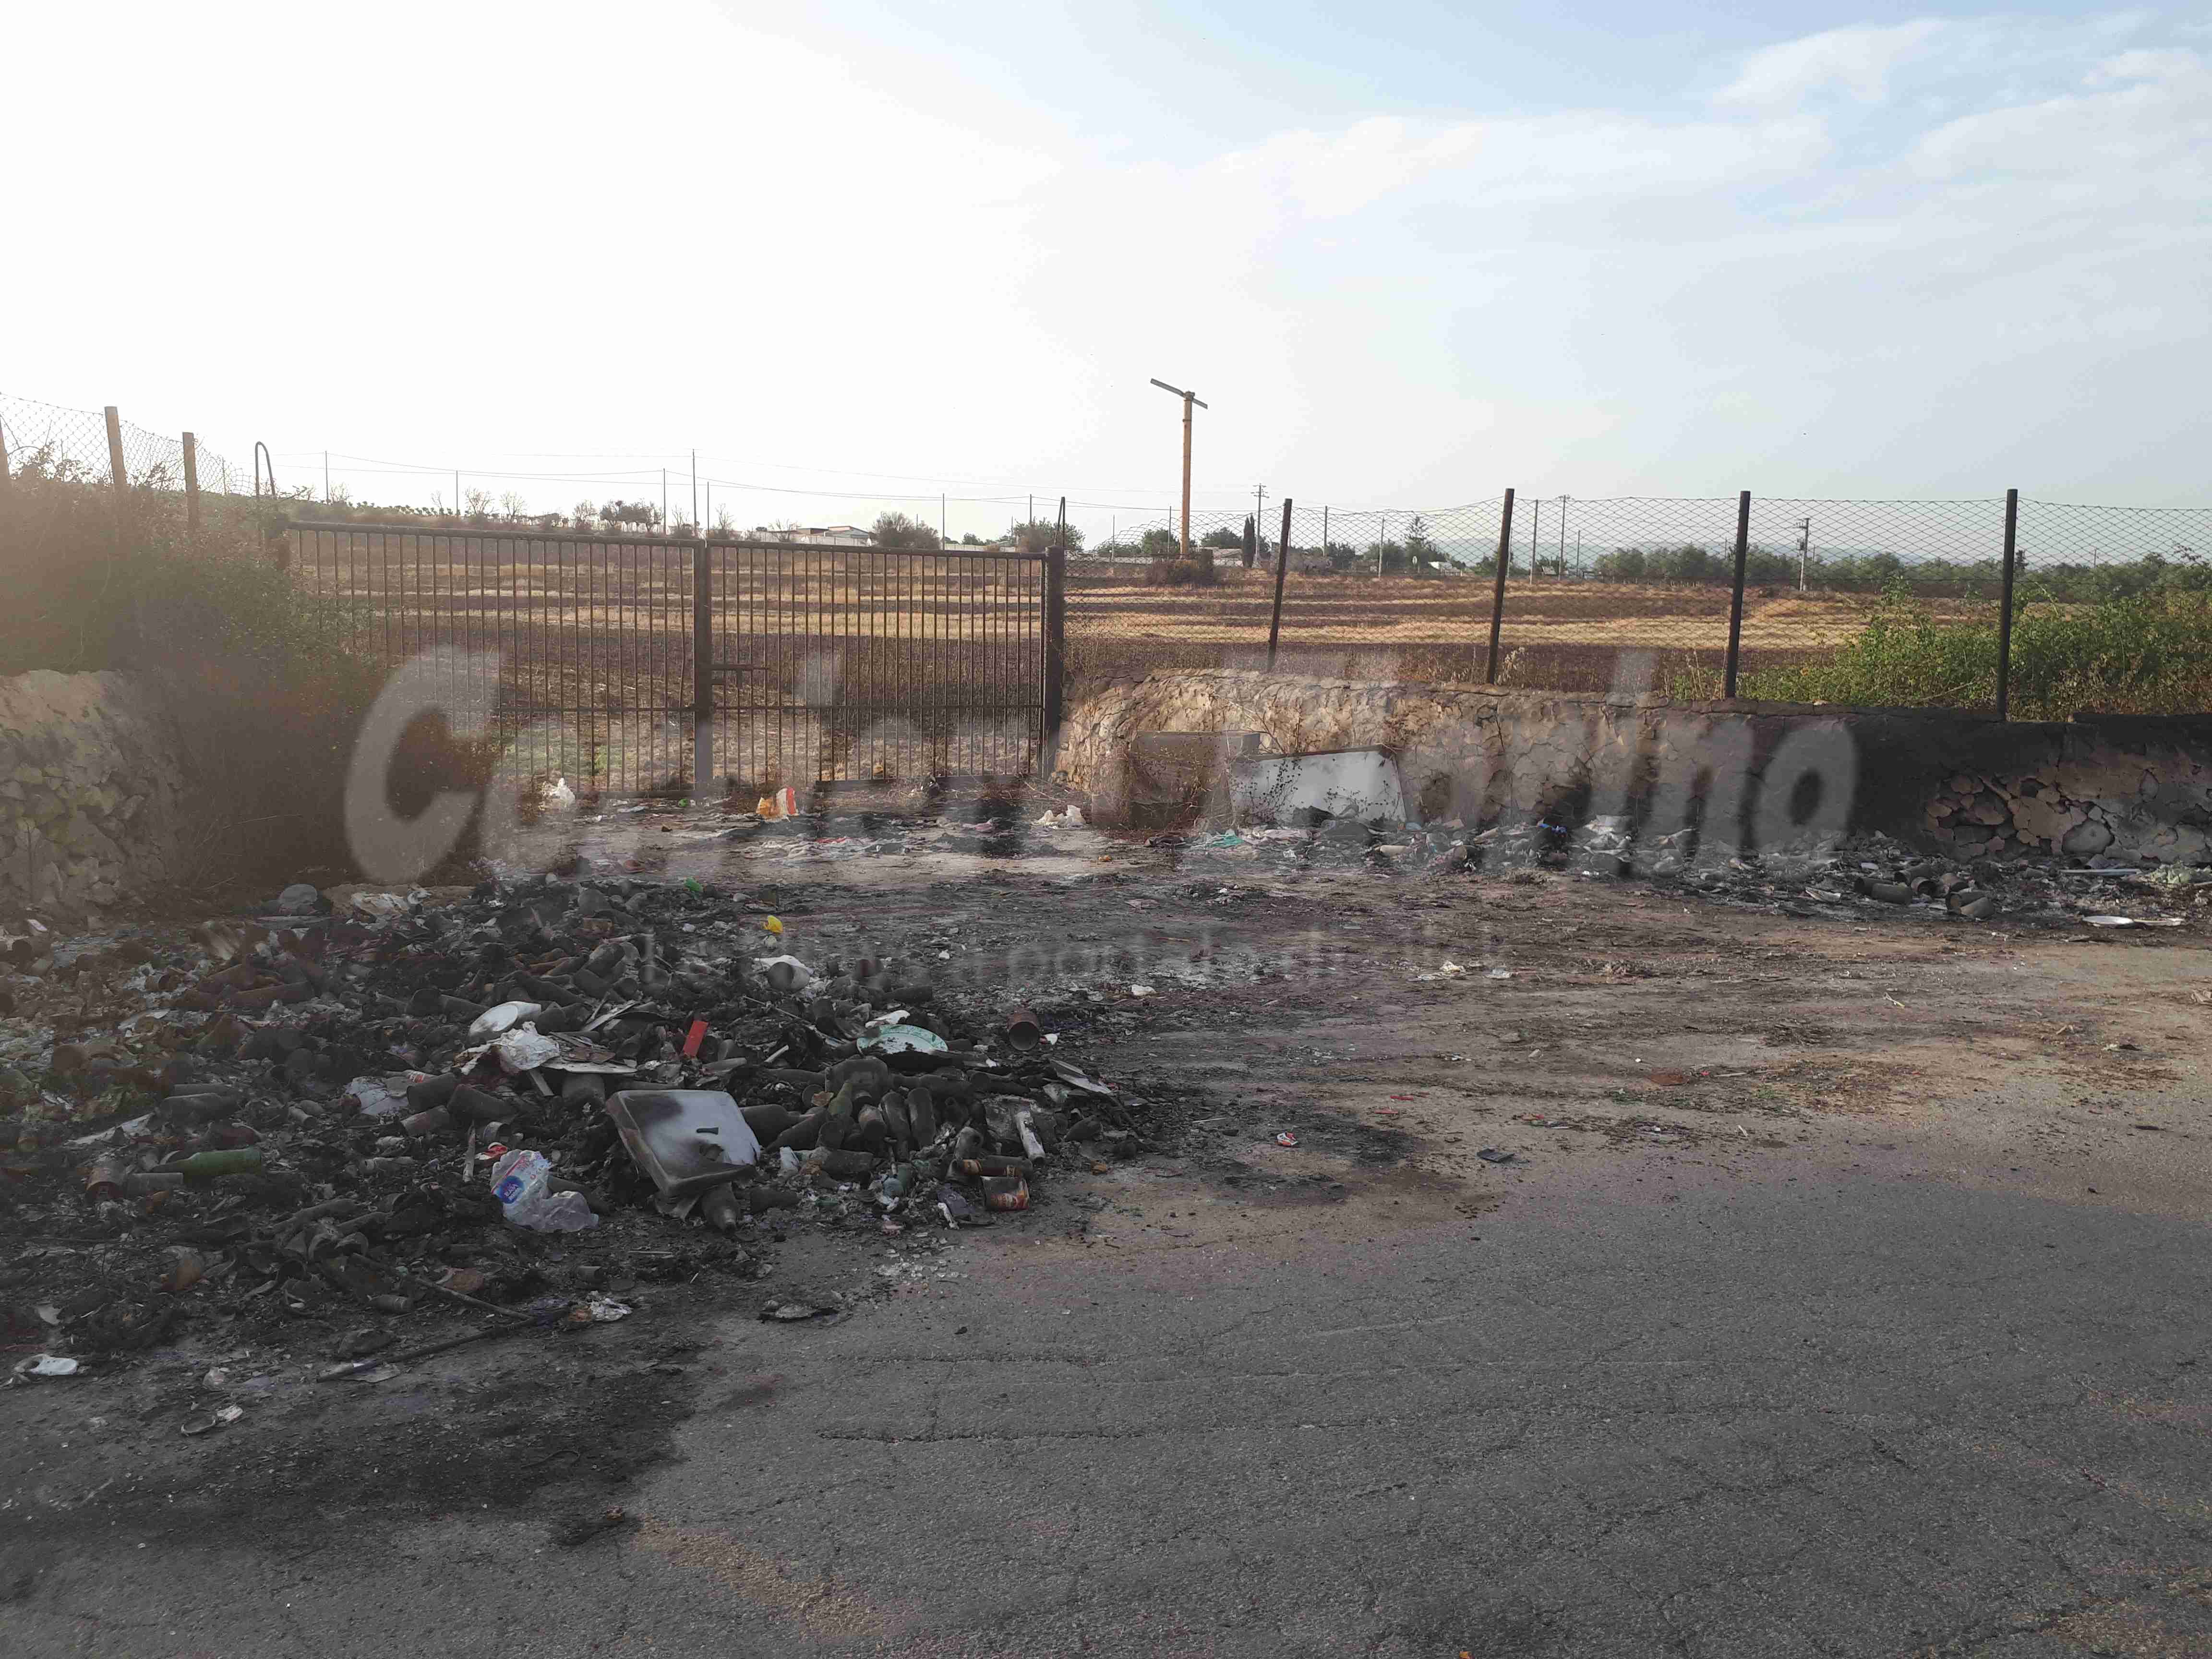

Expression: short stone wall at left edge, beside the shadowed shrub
xmin=0 ymin=668 xmax=183 ymax=914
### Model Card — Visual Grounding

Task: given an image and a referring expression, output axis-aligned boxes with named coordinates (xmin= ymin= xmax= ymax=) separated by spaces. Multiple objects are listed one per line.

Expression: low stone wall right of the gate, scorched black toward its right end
xmin=1059 ymin=670 xmax=2212 ymax=863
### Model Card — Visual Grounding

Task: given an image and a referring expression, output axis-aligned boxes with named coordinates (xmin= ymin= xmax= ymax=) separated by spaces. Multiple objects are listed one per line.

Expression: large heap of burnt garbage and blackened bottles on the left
xmin=0 ymin=878 xmax=1139 ymax=1363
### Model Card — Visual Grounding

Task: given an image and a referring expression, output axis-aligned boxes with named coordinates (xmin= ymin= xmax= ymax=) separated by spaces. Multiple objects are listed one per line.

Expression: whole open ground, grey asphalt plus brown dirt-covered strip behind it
xmin=0 ymin=836 xmax=2212 ymax=1659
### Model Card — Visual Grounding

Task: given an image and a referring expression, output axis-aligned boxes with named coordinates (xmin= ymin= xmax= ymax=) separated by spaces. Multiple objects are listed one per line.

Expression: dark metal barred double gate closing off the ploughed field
xmin=285 ymin=520 xmax=1064 ymax=796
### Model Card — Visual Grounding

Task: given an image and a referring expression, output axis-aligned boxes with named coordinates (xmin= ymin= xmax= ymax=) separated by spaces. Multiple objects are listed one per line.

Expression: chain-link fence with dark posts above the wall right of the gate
xmin=1069 ymin=495 xmax=2212 ymax=717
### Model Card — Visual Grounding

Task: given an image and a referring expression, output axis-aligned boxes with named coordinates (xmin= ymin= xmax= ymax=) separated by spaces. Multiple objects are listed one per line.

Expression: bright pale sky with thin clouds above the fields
xmin=0 ymin=0 xmax=2212 ymax=538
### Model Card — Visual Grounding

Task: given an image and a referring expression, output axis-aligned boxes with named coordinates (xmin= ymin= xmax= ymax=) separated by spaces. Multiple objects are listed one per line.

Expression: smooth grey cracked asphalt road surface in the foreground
xmin=13 ymin=1143 xmax=2212 ymax=1659
